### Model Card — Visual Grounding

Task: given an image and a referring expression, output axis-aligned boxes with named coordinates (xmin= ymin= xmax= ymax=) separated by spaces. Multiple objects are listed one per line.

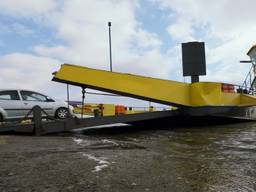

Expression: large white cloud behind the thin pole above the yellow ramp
xmin=31 ymin=0 xmax=176 ymax=78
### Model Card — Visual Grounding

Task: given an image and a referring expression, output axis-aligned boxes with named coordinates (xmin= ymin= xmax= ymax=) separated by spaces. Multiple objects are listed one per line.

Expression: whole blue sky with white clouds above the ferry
xmin=0 ymin=0 xmax=256 ymax=105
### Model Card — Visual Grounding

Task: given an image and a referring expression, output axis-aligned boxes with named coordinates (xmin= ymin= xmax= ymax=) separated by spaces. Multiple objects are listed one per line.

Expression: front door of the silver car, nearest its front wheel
xmin=20 ymin=90 xmax=53 ymax=114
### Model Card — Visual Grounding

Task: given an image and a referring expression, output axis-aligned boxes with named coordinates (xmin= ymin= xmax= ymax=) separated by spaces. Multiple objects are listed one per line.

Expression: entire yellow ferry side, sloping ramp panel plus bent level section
xmin=53 ymin=64 xmax=256 ymax=107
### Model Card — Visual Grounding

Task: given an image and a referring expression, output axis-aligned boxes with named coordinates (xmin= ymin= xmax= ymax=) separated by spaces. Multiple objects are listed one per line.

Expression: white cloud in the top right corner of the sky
xmin=155 ymin=0 xmax=256 ymax=39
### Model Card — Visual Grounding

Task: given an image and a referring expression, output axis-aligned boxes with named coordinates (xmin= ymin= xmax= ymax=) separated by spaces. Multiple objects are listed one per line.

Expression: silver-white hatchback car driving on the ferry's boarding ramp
xmin=0 ymin=90 xmax=73 ymax=121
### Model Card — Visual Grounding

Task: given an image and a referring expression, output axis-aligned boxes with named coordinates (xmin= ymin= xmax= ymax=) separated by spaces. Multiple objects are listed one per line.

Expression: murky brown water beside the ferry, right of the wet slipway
xmin=76 ymin=123 xmax=256 ymax=191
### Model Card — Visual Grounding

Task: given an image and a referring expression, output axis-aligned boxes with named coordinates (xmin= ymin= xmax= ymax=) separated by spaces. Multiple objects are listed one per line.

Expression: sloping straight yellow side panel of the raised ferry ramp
xmin=53 ymin=64 xmax=190 ymax=106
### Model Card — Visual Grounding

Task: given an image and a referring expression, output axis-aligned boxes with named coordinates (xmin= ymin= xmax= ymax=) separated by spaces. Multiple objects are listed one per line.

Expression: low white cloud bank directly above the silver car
xmin=0 ymin=53 xmax=64 ymax=95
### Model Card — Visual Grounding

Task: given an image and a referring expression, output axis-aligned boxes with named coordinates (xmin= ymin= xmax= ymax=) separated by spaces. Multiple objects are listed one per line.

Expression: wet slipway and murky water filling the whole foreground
xmin=0 ymin=123 xmax=256 ymax=192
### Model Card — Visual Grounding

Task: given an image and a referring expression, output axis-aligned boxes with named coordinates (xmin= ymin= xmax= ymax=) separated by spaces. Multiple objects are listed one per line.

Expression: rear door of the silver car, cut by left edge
xmin=0 ymin=90 xmax=24 ymax=119
